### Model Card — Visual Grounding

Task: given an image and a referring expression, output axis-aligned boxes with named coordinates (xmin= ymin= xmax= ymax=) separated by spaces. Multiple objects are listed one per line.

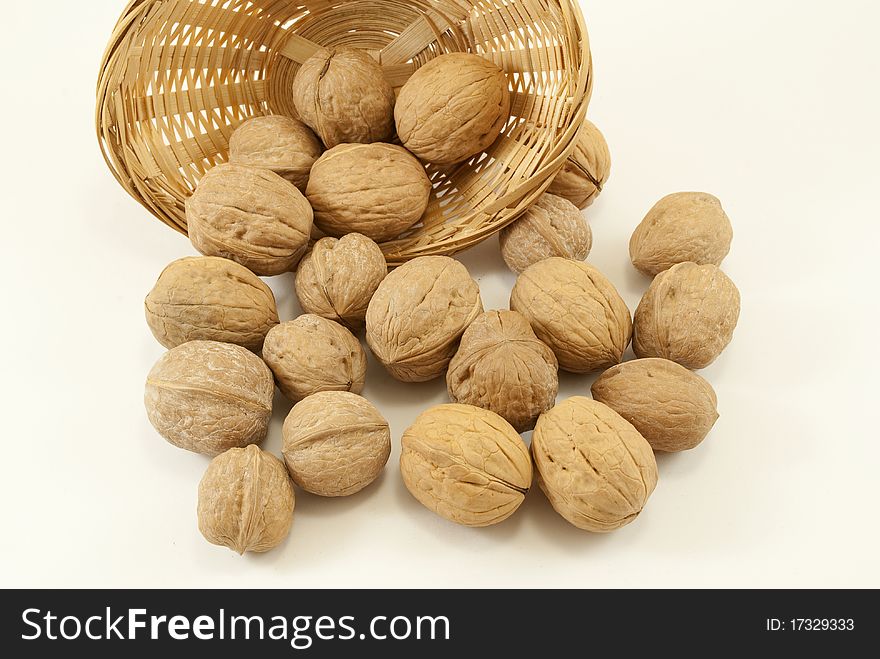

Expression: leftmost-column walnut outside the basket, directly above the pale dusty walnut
xmin=144 ymin=256 xmax=278 ymax=351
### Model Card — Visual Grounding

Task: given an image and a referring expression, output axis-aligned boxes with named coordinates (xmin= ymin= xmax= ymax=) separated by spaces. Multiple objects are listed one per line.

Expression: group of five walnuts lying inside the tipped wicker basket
xmin=186 ymin=48 xmax=510 ymax=262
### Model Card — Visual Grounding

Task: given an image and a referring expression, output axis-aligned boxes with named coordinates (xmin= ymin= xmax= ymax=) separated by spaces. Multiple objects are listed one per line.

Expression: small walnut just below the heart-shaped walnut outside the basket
xmin=263 ymin=314 xmax=367 ymax=402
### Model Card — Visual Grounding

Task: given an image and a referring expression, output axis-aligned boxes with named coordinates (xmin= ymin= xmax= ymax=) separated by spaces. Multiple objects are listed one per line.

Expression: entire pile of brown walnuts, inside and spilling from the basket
xmin=145 ymin=43 xmax=739 ymax=553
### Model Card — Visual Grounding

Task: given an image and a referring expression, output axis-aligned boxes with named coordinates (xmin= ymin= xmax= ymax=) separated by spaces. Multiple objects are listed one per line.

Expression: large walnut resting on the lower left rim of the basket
xmin=186 ymin=165 xmax=312 ymax=277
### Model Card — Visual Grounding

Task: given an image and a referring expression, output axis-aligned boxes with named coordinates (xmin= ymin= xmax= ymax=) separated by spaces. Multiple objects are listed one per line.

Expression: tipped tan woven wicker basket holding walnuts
xmin=96 ymin=0 xmax=592 ymax=265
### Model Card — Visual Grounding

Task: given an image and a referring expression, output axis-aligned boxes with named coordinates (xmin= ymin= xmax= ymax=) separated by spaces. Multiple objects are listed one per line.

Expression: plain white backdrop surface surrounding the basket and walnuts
xmin=0 ymin=0 xmax=880 ymax=588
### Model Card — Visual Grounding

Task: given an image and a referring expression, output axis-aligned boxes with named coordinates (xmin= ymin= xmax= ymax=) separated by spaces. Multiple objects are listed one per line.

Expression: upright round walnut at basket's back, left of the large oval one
xmin=293 ymin=48 xmax=394 ymax=149
